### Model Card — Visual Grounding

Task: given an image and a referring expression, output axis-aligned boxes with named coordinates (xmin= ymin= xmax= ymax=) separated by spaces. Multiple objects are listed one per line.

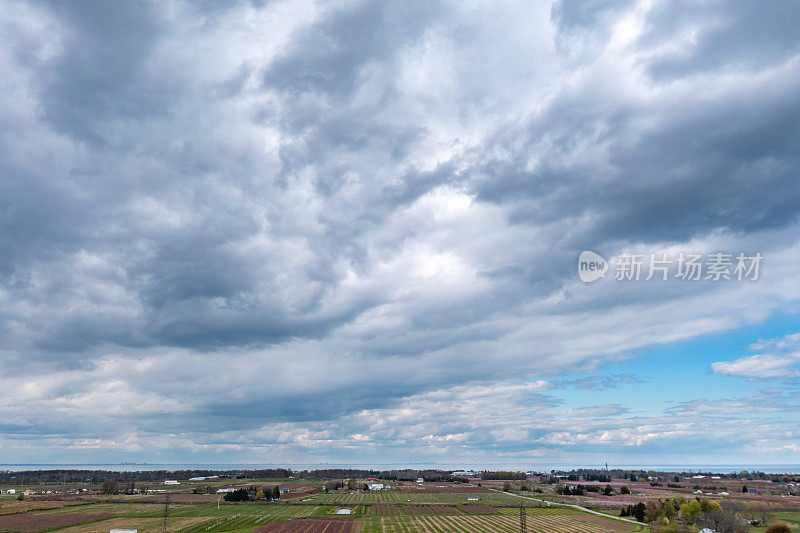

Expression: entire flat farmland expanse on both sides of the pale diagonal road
xmin=0 ymin=472 xmax=800 ymax=533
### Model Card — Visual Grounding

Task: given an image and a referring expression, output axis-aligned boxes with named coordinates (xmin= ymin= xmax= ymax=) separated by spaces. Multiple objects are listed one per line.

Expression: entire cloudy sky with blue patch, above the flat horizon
xmin=0 ymin=0 xmax=800 ymax=466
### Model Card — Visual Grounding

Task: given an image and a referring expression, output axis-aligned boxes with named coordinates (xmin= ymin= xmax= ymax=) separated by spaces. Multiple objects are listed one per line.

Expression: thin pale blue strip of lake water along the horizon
xmin=0 ymin=463 xmax=800 ymax=474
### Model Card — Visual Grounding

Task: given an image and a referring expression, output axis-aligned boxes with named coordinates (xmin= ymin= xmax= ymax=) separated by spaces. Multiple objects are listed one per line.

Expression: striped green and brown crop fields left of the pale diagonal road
xmin=0 ymin=493 xmax=636 ymax=533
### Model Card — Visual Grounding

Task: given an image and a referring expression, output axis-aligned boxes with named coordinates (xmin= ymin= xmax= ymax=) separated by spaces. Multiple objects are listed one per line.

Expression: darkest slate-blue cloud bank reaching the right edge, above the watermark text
xmin=466 ymin=60 xmax=800 ymax=250
